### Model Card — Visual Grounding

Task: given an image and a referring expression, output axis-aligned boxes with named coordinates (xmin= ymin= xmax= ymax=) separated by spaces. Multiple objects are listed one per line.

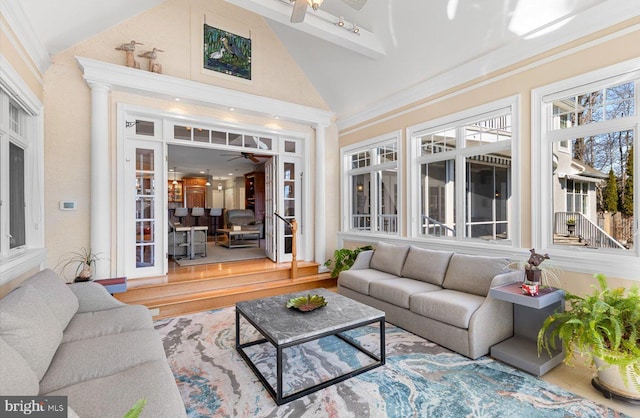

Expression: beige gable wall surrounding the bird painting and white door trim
xmin=44 ymin=0 xmax=337 ymax=271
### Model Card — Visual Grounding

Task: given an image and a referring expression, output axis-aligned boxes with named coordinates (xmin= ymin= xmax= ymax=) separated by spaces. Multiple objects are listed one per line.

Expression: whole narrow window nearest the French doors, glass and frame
xmin=342 ymin=134 xmax=400 ymax=234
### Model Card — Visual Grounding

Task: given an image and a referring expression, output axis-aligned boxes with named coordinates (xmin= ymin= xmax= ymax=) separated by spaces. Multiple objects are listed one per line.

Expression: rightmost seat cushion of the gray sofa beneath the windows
xmin=410 ymin=289 xmax=485 ymax=329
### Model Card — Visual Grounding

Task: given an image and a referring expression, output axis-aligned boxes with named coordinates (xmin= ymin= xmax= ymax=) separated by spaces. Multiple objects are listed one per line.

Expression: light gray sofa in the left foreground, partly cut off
xmin=0 ymin=269 xmax=186 ymax=418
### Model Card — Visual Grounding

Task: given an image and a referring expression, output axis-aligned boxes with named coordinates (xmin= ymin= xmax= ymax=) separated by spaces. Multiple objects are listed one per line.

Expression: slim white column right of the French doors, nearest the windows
xmin=314 ymin=124 xmax=327 ymax=266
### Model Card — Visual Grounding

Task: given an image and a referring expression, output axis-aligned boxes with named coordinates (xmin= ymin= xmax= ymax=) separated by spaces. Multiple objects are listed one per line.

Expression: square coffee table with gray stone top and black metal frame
xmin=236 ymin=289 xmax=385 ymax=405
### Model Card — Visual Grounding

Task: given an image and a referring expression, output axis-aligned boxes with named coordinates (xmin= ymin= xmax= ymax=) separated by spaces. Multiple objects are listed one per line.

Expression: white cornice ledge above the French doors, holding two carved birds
xmin=76 ymin=57 xmax=335 ymax=127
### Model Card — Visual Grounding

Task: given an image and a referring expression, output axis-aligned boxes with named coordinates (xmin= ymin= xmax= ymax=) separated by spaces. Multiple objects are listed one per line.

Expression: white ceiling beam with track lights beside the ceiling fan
xmin=225 ymin=0 xmax=386 ymax=59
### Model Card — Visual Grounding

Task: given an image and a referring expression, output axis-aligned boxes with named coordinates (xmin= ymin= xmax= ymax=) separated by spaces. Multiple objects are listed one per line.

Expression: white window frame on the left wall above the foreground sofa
xmin=0 ymin=54 xmax=46 ymax=286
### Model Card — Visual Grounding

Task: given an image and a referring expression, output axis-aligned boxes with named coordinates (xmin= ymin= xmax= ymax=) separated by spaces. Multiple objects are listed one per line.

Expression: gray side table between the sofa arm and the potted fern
xmin=489 ymin=282 xmax=564 ymax=376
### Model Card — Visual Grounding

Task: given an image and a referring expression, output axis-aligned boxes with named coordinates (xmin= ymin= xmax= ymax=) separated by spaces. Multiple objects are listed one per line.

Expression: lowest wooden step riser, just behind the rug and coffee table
xmin=149 ymin=279 xmax=336 ymax=319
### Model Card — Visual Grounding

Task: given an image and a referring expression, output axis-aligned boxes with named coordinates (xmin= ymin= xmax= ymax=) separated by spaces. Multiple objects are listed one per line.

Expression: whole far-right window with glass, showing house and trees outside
xmin=532 ymin=60 xmax=640 ymax=277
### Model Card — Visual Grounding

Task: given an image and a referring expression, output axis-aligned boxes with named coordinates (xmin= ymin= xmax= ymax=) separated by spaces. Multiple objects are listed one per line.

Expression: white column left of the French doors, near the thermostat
xmin=88 ymin=82 xmax=111 ymax=279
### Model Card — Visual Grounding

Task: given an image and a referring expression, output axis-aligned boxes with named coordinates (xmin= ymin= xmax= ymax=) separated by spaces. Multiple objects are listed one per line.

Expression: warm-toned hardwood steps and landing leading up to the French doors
xmin=115 ymin=260 xmax=336 ymax=319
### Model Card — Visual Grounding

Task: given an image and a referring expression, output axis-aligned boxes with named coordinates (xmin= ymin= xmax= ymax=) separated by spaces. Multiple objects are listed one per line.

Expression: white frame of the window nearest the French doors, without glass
xmin=340 ymin=131 xmax=403 ymax=237
